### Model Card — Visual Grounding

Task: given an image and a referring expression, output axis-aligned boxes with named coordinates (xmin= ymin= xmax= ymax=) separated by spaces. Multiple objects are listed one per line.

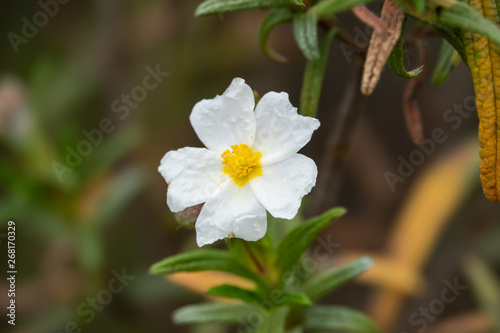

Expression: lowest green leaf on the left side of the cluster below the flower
xmin=172 ymin=303 xmax=260 ymax=324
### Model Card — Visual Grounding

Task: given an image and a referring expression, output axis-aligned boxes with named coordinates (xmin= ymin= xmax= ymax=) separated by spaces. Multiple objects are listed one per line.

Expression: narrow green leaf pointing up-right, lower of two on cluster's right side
xmin=304 ymin=257 xmax=373 ymax=301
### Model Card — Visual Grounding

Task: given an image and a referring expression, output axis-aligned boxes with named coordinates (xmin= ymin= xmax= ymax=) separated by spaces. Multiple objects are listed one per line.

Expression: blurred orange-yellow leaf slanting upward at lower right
xmin=366 ymin=142 xmax=478 ymax=330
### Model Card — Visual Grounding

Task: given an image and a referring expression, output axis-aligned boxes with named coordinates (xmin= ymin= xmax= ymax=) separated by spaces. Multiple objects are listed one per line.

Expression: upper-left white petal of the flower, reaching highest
xmin=189 ymin=78 xmax=255 ymax=154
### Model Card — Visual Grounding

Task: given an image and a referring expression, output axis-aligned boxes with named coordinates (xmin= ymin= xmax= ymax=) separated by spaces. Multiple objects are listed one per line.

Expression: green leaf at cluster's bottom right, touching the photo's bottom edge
xmin=305 ymin=306 xmax=380 ymax=333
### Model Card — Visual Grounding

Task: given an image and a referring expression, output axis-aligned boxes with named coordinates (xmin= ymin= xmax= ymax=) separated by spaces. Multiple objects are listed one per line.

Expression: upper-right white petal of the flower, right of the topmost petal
xmin=253 ymin=92 xmax=319 ymax=165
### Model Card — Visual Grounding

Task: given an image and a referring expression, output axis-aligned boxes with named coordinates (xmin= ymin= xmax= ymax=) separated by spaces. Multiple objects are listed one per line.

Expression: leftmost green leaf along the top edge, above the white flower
xmin=195 ymin=0 xmax=288 ymax=16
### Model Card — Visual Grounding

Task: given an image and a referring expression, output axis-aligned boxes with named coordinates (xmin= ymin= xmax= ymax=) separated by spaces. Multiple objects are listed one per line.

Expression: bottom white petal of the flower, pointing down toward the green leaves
xmin=196 ymin=182 xmax=267 ymax=247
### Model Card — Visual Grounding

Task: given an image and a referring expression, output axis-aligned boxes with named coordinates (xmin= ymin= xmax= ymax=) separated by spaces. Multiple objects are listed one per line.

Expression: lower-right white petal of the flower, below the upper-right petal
xmin=250 ymin=154 xmax=318 ymax=219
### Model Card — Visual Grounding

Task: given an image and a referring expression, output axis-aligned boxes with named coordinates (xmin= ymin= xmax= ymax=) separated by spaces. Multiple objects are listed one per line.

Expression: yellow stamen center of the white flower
xmin=221 ymin=143 xmax=262 ymax=186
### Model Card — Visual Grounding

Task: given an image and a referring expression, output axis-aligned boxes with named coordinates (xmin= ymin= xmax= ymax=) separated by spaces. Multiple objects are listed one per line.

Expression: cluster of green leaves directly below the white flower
xmin=150 ymin=208 xmax=378 ymax=332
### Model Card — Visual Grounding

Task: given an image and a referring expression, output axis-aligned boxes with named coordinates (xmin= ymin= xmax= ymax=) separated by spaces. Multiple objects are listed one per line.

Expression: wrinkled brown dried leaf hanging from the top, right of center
xmin=361 ymin=0 xmax=404 ymax=95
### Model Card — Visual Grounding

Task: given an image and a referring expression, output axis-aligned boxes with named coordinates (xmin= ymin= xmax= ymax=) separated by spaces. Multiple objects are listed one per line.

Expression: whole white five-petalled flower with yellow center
xmin=158 ymin=78 xmax=319 ymax=247
